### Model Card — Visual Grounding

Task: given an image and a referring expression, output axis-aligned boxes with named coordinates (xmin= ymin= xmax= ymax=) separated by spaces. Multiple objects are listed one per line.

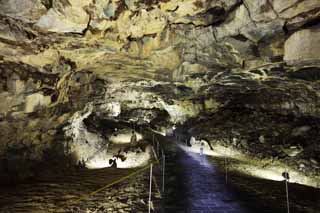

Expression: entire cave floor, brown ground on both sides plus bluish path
xmin=0 ymin=136 xmax=320 ymax=213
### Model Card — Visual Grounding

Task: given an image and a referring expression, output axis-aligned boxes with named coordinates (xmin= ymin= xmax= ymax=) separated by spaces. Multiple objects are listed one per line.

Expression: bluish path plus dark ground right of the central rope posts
xmin=162 ymin=136 xmax=320 ymax=213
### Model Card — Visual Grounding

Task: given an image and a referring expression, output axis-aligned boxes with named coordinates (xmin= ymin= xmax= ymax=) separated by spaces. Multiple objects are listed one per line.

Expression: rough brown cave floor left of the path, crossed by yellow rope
xmin=0 ymin=168 xmax=157 ymax=213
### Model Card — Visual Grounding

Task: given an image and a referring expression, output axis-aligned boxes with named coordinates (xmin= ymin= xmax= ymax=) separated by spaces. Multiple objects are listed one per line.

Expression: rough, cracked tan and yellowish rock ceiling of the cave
xmin=0 ymin=0 xmax=320 ymax=186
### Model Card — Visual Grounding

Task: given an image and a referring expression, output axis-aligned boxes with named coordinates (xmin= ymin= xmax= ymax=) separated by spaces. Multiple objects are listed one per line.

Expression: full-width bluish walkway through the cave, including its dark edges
xmin=162 ymin=137 xmax=261 ymax=213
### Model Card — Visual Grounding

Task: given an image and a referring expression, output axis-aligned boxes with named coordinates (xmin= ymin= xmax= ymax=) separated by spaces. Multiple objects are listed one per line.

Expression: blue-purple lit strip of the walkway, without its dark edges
xmin=179 ymin=148 xmax=248 ymax=213
